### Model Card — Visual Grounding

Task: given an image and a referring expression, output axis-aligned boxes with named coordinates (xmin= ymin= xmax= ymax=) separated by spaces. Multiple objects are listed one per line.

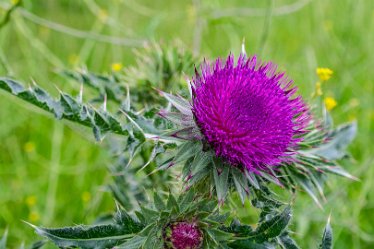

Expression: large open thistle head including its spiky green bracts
xmin=159 ymin=55 xmax=356 ymax=204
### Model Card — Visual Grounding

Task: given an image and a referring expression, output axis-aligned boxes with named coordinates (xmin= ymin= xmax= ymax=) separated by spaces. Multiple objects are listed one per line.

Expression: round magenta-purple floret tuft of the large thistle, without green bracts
xmin=192 ymin=55 xmax=309 ymax=173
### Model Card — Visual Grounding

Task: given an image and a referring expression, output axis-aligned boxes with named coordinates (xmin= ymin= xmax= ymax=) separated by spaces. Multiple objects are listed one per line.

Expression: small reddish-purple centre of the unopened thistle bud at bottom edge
xmin=164 ymin=222 xmax=203 ymax=249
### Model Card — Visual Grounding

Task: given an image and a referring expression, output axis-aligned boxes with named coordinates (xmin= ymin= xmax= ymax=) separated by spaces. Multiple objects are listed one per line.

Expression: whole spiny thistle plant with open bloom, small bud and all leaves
xmin=0 ymin=44 xmax=357 ymax=249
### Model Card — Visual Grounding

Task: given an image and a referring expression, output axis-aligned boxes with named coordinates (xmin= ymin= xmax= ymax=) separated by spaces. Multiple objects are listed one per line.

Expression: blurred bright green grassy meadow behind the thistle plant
xmin=0 ymin=0 xmax=374 ymax=249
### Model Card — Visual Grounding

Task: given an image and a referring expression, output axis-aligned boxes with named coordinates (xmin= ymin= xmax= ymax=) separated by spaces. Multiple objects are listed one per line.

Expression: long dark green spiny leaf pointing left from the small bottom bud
xmin=27 ymin=220 xmax=142 ymax=249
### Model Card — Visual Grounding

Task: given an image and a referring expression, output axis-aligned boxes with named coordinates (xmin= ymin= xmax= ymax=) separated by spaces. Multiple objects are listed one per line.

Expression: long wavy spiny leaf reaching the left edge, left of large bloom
xmin=0 ymin=78 xmax=129 ymax=140
